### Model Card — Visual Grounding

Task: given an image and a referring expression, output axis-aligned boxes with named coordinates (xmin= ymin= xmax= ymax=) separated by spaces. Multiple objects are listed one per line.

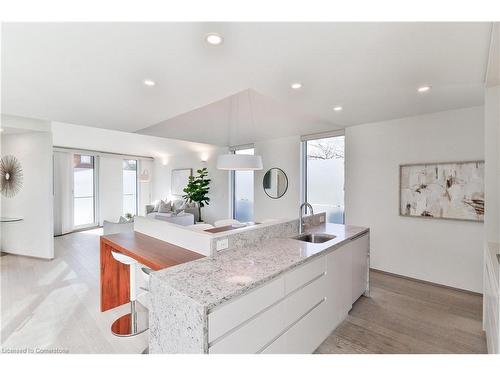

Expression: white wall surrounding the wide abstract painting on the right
xmin=345 ymin=107 xmax=484 ymax=292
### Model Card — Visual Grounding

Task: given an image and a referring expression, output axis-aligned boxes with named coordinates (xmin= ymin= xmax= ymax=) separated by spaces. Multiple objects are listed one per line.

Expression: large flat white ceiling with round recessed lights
xmin=2 ymin=23 xmax=491 ymax=141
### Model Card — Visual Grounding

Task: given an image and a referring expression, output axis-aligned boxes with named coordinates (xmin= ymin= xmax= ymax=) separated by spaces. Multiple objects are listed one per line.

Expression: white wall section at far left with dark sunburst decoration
xmin=1 ymin=123 xmax=54 ymax=259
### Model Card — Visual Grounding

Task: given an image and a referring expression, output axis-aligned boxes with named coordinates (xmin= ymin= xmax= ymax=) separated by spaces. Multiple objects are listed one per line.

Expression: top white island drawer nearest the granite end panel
xmin=208 ymin=277 xmax=284 ymax=343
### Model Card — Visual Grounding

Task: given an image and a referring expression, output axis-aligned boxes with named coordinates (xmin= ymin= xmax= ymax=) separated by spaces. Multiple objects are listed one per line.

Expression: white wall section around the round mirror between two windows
xmin=254 ymin=136 xmax=300 ymax=221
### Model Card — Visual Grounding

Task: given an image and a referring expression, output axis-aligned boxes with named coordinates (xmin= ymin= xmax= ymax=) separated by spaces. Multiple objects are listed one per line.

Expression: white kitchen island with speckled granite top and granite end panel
xmin=150 ymin=224 xmax=369 ymax=353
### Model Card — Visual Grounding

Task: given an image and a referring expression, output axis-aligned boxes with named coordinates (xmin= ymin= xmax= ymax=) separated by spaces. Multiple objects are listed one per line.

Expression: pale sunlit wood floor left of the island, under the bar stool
xmin=0 ymin=229 xmax=149 ymax=353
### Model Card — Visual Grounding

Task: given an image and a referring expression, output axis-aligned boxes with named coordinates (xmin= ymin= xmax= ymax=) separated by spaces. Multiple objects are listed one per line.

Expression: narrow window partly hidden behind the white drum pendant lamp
xmin=232 ymin=148 xmax=254 ymax=222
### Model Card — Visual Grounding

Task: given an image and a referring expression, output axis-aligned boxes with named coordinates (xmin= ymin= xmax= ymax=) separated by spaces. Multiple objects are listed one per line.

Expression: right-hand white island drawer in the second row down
xmin=285 ymin=274 xmax=327 ymax=327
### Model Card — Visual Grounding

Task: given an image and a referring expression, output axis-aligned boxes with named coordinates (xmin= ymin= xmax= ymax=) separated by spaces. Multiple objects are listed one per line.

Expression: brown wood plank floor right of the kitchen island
xmin=316 ymin=271 xmax=486 ymax=354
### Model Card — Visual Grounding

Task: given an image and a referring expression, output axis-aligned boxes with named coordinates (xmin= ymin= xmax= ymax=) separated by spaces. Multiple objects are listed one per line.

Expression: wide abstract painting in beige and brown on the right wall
xmin=399 ymin=161 xmax=484 ymax=221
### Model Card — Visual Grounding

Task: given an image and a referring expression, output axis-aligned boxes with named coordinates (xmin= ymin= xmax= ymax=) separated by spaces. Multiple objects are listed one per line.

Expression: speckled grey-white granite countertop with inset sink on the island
xmin=151 ymin=223 xmax=368 ymax=310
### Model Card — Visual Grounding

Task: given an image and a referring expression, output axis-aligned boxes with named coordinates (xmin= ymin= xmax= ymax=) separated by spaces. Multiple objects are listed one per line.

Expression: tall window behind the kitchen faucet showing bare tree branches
xmin=303 ymin=136 xmax=345 ymax=224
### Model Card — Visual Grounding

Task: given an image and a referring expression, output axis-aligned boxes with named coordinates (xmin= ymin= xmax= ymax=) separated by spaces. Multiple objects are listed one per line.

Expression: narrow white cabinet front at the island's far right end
xmin=348 ymin=234 xmax=370 ymax=303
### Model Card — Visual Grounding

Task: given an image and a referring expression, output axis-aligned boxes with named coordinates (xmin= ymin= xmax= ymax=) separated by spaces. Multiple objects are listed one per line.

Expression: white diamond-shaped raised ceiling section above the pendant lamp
xmin=139 ymin=89 xmax=335 ymax=146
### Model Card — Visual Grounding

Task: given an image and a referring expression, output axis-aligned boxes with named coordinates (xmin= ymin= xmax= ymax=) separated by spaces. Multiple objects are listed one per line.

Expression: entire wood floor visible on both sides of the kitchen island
xmin=0 ymin=229 xmax=486 ymax=353
